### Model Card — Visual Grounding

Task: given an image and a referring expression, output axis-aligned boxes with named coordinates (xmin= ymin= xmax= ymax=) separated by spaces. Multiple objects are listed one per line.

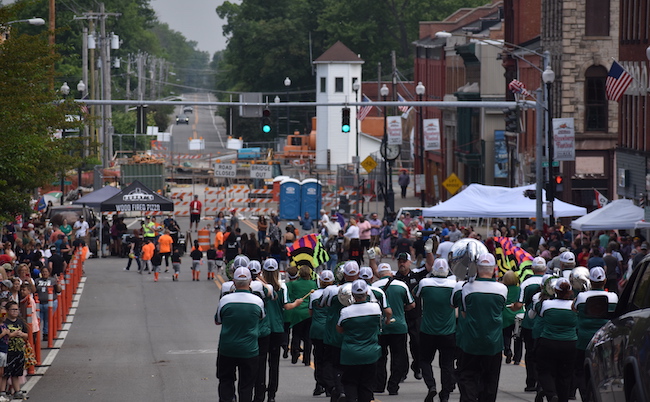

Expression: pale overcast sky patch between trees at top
xmin=150 ymin=0 xmax=235 ymax=58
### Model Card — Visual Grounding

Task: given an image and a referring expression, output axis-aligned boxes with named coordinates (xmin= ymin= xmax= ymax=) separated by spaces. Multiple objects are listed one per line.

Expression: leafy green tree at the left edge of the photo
xmin=0 ymin=7 xmax=79 ymax=220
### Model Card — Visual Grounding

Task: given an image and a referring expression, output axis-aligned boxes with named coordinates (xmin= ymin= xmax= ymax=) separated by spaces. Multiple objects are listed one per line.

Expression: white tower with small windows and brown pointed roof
xmin=314 ymin=41 xmax=364 ymax=169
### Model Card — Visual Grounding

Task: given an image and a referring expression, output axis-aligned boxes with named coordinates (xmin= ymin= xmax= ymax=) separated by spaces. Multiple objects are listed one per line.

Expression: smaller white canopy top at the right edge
xmin=571 ymin=199 xmax=650 ymax=231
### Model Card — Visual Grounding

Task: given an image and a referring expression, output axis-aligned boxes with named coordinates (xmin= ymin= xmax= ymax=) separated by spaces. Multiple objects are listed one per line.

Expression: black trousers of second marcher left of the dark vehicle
xmin=537 ymin=338 xmax=576 ymax=402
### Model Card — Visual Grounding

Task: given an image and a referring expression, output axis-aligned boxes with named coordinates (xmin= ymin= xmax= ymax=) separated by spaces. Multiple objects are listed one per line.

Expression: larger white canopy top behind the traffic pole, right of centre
xmin=422 ymin=183 xmax=587 ymax=218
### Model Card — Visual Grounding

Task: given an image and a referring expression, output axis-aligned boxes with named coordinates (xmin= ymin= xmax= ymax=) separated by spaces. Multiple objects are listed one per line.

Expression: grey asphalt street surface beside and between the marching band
xmin=24 ymin=240 xmax=552 ymax=402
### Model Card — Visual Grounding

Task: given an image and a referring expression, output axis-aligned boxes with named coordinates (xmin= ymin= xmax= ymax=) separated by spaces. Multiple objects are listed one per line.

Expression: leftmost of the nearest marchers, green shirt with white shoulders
xmin=214 ymin=267 xmax=265 ymax=402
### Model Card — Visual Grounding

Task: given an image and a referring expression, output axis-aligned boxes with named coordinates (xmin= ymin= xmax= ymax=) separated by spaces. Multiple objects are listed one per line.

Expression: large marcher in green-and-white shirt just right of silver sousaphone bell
xmin=458 ymin=253 xmax=508 ymax=402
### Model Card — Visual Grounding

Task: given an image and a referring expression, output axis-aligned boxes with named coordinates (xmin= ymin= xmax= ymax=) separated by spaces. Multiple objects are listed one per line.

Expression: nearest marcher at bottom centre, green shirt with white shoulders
xmin=336 ymin=279 xmax=381 ymax=402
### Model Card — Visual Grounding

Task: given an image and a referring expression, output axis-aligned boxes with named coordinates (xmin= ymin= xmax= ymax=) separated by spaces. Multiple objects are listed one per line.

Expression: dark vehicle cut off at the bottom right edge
xmin=585 ymin=257 xmax=650 ymax=402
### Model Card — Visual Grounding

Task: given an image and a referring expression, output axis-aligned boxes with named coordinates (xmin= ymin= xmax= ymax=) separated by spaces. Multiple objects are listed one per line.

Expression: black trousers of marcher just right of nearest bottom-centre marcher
xmin=375 ymin=334 xmax=409 ymax=392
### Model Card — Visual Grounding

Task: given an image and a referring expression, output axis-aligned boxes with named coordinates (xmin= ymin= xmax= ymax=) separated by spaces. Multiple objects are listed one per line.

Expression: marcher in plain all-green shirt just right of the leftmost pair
xmin=287 ymin=265 xmax=317 ymax=366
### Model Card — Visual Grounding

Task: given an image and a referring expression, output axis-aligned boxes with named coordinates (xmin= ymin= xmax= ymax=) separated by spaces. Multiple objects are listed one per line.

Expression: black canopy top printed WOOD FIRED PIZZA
xmin=100 ymin=180 xmax=174 ymax=214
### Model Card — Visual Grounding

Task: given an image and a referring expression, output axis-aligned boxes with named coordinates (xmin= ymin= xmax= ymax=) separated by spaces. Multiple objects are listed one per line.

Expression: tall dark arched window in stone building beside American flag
xmin=585 ymin=66 xmax=607 ymax=132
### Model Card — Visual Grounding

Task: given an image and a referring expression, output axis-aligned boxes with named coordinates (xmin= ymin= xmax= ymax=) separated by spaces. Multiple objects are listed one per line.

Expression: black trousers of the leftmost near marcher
xmin=217 ymin=354 xmax=259 ymax=402
